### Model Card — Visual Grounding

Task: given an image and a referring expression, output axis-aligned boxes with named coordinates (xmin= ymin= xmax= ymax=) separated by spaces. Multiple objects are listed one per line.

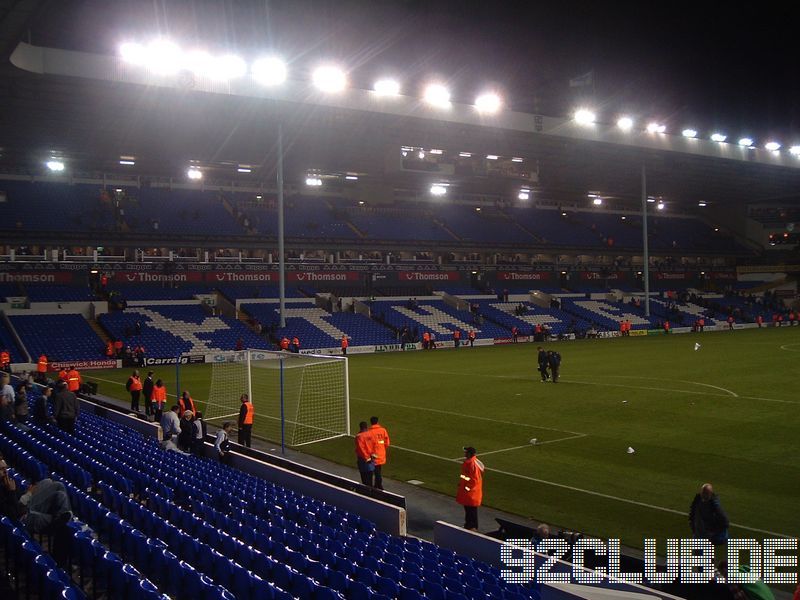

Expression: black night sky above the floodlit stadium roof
xmin=32 ymin=0 xmax=800 ymax=146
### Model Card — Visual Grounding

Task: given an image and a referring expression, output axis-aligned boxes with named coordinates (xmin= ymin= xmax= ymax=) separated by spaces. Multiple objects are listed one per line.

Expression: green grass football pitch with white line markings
xmin=85 ymin=327 xmax=800 ymax=548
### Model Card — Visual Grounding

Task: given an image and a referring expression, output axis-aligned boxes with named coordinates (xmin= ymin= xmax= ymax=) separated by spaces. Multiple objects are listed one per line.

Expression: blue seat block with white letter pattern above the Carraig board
xmin=99 ymin=304 xmax=269 ymax=357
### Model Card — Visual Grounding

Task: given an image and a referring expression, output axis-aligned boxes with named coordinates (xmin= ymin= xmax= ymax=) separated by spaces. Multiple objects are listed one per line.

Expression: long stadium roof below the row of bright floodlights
xmin=0 ymin=2 xmax=800 ymax=206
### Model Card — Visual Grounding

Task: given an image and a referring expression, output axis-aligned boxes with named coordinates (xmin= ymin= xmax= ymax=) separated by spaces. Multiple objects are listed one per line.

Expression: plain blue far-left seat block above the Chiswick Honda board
xmin=9 ymin=314 xmax=104 ymax=361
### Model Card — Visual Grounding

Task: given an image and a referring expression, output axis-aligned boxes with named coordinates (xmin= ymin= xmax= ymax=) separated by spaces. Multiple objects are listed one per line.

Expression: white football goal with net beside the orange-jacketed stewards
xmin=205 ymin=350 xmax=350 ymax=446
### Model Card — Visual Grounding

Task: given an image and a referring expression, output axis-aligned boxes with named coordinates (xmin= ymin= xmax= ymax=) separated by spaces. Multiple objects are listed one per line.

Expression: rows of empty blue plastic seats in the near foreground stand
xmin=0 ymin=398 xmax=540 ymax=600
